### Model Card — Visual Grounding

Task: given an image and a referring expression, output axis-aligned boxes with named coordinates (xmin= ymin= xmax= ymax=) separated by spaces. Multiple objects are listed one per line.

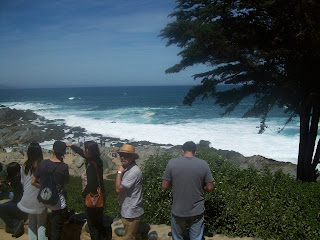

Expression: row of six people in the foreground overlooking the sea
xmin=0 ymin=141 xmax=213 ymax=240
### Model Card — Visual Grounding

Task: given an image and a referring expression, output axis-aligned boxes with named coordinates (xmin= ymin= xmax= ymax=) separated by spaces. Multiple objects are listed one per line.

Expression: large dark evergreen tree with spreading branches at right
xmin=160 ymin=0 xmax=320 ymax=181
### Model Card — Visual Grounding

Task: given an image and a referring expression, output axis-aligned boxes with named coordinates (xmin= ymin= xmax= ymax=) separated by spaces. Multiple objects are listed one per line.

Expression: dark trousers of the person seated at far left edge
xmin=0 ymin=201 xmax=27 ymax=229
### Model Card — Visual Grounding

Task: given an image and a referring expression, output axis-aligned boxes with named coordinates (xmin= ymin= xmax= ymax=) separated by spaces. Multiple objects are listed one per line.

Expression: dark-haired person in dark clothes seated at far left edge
xmin=0 ymin=162 xmax=27 ymax=237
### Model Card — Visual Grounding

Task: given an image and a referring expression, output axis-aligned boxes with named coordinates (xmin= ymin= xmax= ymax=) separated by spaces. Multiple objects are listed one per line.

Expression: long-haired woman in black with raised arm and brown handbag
xmin=67 ymin=141 xmax=105 ymax=240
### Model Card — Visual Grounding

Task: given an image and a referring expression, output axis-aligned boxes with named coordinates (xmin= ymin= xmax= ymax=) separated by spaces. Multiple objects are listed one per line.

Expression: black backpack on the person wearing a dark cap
xmin=37 ymin=162 xmax=60 ymax=205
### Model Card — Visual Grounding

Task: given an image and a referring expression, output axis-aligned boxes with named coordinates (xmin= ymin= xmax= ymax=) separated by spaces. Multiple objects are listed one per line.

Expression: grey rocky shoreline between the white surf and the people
xmin=0 ymin=105 xmax=296 ymax=177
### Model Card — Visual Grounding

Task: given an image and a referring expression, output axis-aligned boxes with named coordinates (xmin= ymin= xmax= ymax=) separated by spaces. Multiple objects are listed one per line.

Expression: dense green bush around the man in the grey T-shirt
xmin=143 ymin=148 xmax=320 ymax=240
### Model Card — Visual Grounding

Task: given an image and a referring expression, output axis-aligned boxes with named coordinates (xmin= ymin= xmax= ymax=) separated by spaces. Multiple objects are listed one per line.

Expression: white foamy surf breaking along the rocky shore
xmin=6 ymin=103 xmax=299 ymax=164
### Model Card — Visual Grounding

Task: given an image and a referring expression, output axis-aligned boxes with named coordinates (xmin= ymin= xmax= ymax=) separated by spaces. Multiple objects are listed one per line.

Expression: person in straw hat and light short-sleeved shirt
xmin=115 ymin=144 xmax=144 ymax=240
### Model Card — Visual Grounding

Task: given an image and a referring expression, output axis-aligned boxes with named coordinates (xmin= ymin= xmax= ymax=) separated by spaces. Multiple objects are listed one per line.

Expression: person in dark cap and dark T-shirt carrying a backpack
xmin=31 ymin=141 xmax=69 ymax=240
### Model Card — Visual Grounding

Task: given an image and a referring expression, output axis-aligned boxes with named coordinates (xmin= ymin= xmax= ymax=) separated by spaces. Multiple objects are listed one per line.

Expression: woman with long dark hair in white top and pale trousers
xmin=18 ymin=143 xmax=48 ymax=240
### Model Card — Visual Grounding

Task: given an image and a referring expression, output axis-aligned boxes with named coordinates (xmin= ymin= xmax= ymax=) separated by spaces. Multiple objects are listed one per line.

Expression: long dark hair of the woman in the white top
xmin=24 ymin=143 xmax=43 ymax=175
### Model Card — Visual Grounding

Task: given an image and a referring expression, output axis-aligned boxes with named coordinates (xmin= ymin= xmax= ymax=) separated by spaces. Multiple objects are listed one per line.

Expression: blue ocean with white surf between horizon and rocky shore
xmin=0 ymin=86 xmax=299 ymax=164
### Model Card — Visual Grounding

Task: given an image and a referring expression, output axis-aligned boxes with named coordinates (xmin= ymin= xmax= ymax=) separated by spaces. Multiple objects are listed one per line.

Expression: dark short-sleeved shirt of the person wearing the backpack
xmin=33 ymin=159 xmax=69 ymax=210
